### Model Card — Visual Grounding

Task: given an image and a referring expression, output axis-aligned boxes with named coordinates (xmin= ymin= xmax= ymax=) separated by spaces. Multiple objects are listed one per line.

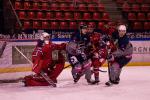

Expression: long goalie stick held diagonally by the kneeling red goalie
xmin=15 ymin=46 xmax=56 ymax=87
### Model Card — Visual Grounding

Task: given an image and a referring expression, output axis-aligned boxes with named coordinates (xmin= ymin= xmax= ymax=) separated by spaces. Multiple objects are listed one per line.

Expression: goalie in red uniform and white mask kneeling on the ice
xmin=24 ymin=33 xmax=65 ymax=86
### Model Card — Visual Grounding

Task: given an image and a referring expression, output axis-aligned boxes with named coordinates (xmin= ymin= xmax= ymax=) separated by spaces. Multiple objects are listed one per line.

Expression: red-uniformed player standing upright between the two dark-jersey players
xmin=88 ymin=25 xmax=107 ymax=84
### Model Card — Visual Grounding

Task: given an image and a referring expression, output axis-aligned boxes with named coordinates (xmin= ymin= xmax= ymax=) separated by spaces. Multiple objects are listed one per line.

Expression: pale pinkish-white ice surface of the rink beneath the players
xmin=0 ymin=66 xmax=150 ymax=100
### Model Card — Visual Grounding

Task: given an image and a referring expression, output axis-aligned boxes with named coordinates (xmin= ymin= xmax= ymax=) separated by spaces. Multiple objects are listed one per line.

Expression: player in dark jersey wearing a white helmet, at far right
xmin=105 ymin=25 xmax=133 ymax=86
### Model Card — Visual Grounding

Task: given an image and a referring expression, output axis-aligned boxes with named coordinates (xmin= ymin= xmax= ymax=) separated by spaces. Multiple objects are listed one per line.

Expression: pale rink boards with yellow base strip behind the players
xmin=0 ymin=41 xmax=150 ymax=73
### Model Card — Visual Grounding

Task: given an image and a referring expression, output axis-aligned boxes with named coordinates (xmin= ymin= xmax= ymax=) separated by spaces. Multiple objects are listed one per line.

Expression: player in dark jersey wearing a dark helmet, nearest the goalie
xmin=67 ymin=25 xmax=92 ymax=83
